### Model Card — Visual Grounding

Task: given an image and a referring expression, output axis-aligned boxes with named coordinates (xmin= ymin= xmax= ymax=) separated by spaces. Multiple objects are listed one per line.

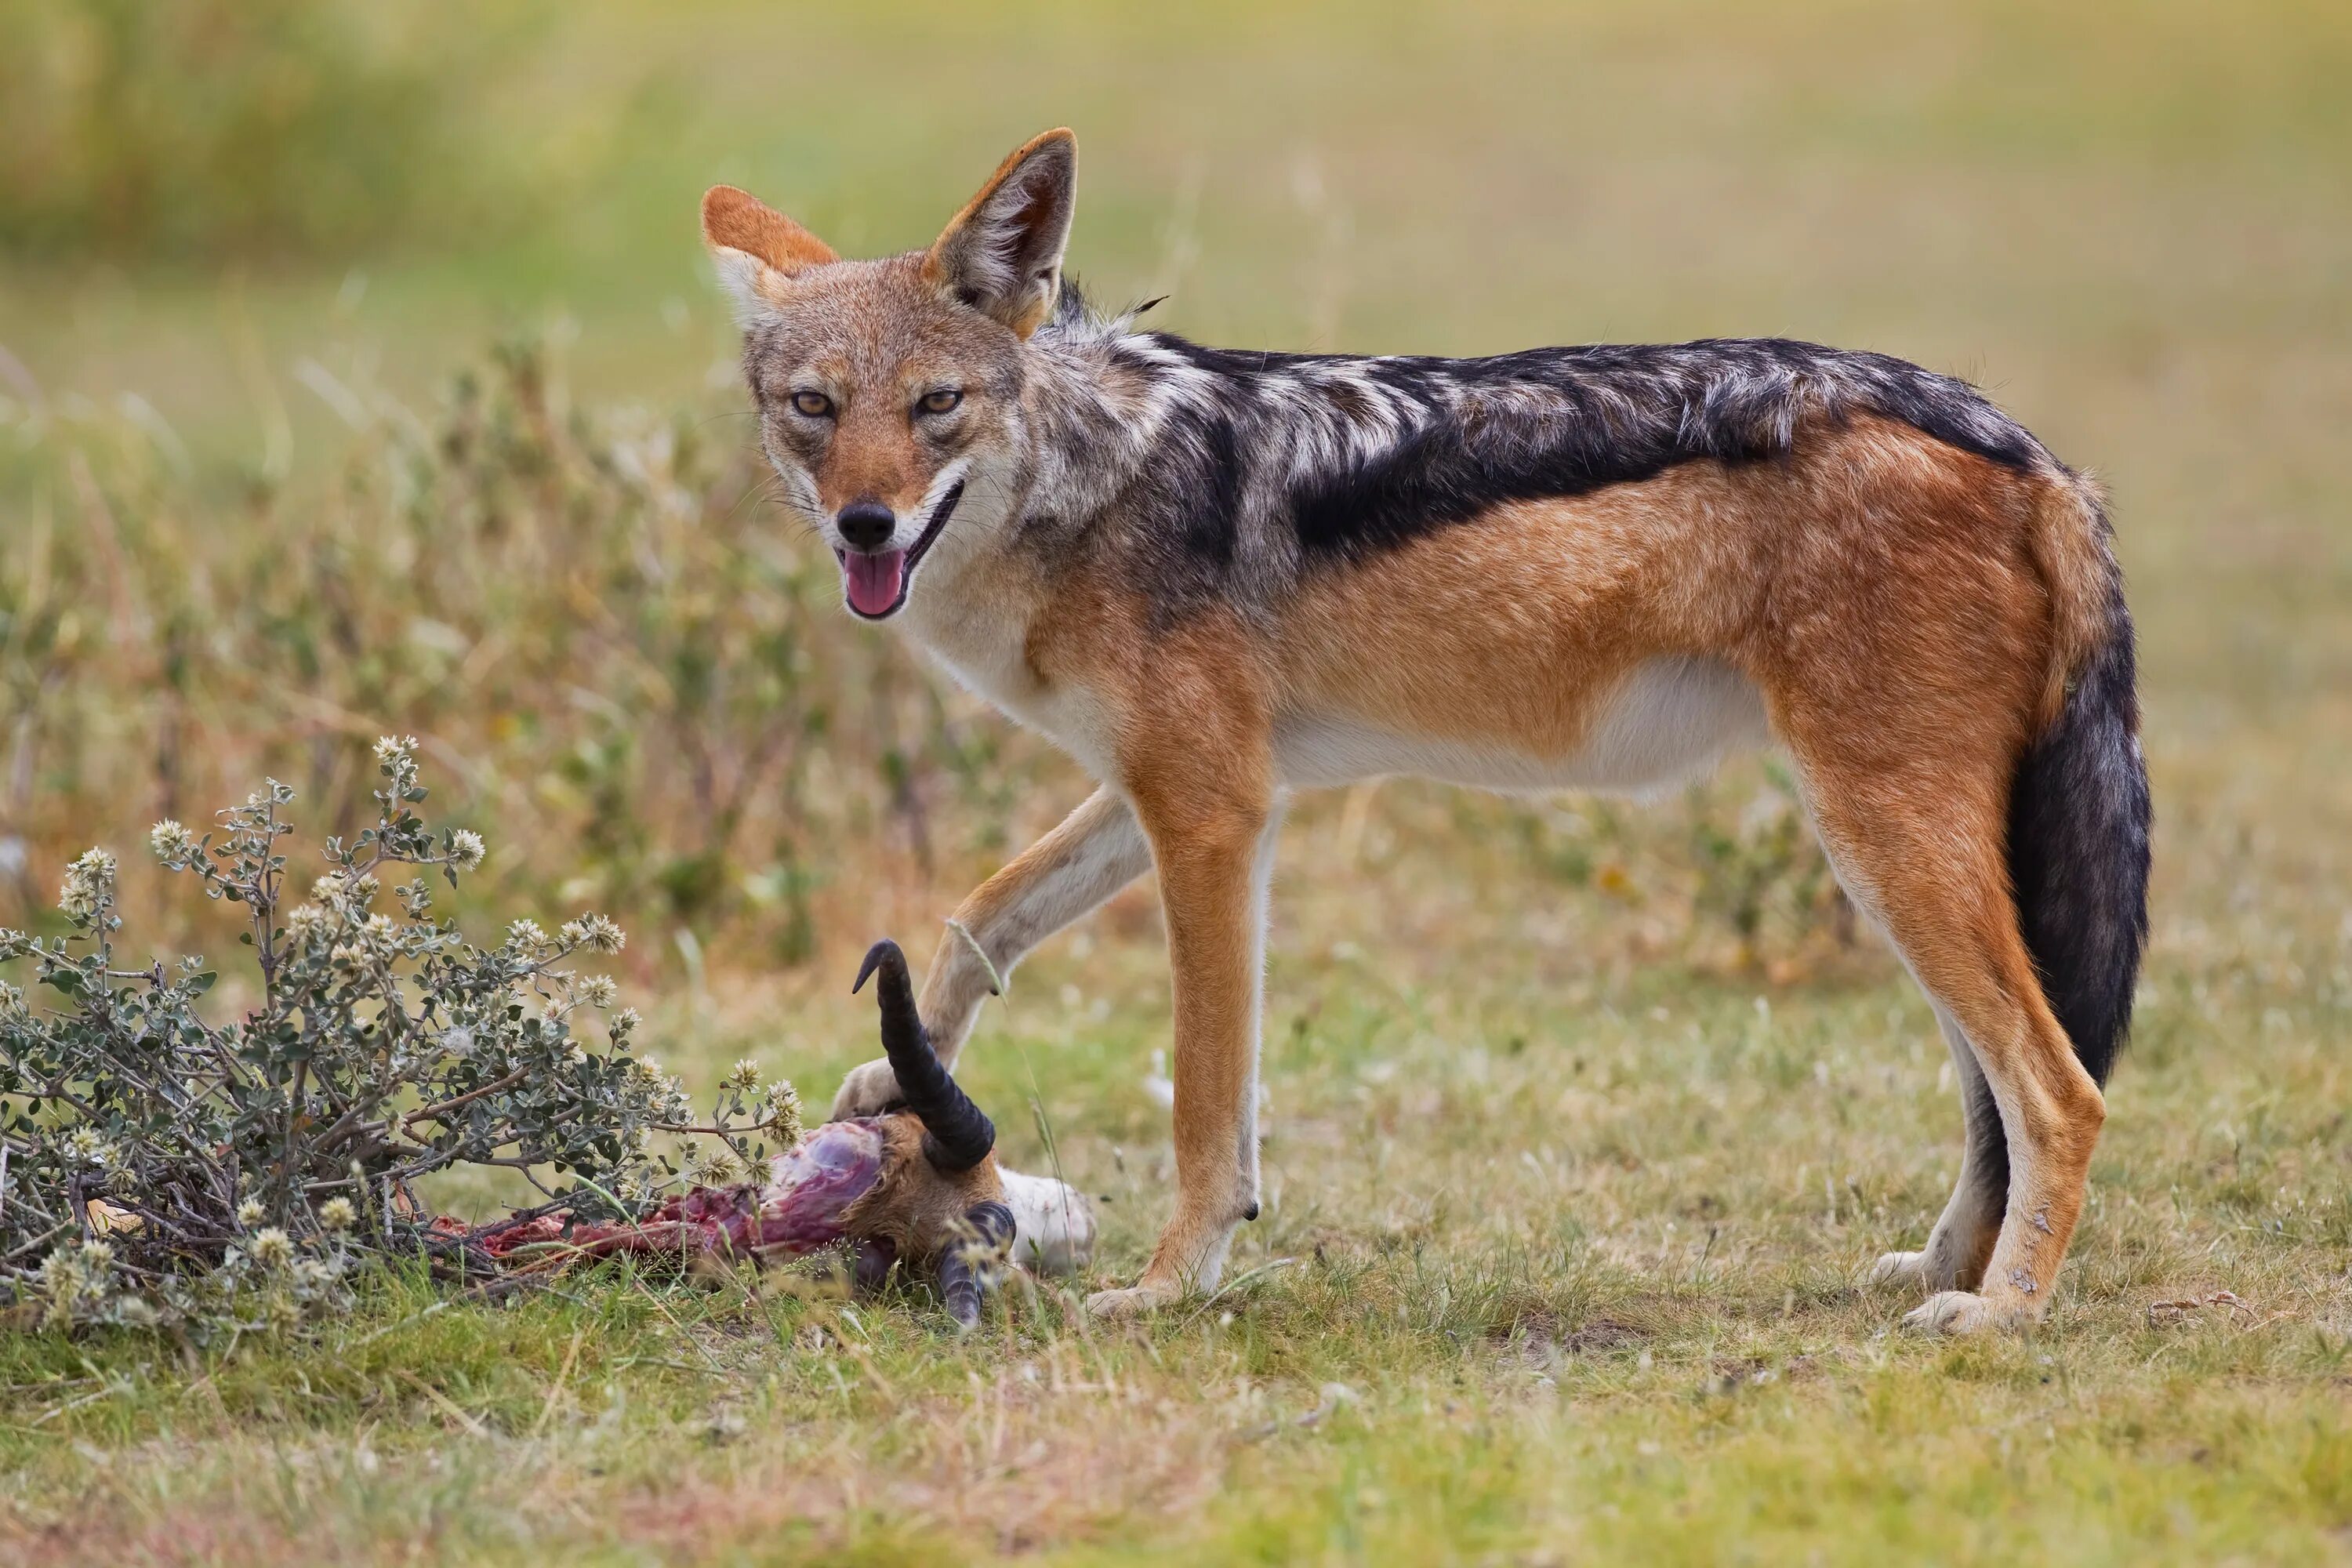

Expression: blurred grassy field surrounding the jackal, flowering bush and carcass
xmin=0 ymin=12 xmax=2352 ymax=1563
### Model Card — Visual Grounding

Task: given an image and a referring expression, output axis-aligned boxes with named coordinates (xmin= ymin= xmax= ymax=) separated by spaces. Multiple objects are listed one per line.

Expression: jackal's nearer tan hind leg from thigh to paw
xmin=1748 ymin=428 xmax=2105 ymax=1326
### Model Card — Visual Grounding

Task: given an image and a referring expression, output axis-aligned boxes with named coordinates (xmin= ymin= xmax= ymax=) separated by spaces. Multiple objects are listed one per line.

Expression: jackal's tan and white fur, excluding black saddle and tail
xmin=706 ymin=132 xmax=2112 ymax=1328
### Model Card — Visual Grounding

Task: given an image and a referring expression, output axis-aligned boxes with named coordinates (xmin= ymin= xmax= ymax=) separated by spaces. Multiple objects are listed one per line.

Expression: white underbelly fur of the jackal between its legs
xmin=1275 ymin=656 xmax=1769 ymax=792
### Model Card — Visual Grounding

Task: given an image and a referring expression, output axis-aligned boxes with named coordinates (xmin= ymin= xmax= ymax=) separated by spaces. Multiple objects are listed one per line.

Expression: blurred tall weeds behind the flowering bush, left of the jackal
xmin=0 ymin=343 xmax=1030 ymax=961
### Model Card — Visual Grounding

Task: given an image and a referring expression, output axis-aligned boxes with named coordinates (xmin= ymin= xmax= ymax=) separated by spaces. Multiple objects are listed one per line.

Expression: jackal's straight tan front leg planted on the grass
xmin=1087 ymin=799 xmax=1279 ymax=1316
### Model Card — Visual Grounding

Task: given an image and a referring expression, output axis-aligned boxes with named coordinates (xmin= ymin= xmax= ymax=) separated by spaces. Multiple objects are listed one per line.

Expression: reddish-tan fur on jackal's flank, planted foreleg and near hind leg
xmin=1096 ymin=419 xmax=2103 ymax=1316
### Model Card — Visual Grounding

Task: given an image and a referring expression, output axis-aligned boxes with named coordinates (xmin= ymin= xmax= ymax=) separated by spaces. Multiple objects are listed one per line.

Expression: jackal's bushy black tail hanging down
xmin=2009 ymin=583 xmax=2150 ymax=1083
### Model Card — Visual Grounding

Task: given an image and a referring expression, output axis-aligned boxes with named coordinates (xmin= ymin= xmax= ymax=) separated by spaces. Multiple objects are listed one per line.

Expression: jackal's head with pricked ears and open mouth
xmin=703 ymin=129 xmax=1077 ymax=621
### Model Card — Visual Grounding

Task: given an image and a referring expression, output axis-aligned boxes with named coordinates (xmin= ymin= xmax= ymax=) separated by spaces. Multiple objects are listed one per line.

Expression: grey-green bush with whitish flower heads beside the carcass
xmin=0 ymin=739 xmax=800 ymax=1333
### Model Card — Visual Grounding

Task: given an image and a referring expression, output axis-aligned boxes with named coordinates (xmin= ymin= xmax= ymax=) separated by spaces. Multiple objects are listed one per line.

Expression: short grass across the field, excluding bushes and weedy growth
xmin=0 ymin=0 xmax=2352 ymax=1563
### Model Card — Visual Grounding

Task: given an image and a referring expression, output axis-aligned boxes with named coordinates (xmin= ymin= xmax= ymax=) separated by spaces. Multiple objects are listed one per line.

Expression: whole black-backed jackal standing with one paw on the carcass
xmin=703 ymin=132 xmax=2150 ymax=1330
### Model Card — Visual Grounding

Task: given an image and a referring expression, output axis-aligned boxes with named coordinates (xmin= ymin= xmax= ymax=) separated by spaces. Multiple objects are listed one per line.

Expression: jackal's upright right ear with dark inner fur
xmin=922 ymin=129 xmax=1077 ymax=336
